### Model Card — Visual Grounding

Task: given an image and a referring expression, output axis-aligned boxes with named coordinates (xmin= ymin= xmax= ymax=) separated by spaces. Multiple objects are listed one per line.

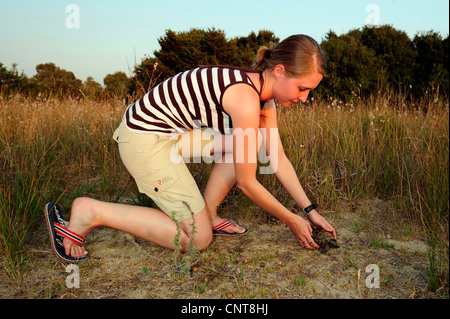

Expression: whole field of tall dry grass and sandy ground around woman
xmin=0 ymin=93 xmax=449 ymax=299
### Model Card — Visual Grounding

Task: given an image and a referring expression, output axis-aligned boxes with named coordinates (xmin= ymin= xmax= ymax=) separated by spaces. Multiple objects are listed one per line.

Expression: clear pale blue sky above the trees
xmin=0 ymin=0 xmax=449 ymax=85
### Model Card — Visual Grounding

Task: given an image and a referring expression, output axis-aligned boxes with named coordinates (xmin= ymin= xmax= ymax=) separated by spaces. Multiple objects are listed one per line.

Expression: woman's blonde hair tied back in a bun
xmin=253 ymin=34 xmax=327 ymax=77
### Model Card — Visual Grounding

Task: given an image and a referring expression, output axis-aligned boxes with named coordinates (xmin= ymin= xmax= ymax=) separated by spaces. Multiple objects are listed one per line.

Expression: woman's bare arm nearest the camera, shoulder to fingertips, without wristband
xmin=223 ymin=85 xmax=318 ymax=248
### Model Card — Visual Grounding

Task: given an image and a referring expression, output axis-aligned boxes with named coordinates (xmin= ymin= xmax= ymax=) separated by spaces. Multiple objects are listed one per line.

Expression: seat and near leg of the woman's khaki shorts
xmin=113 ymin=121 xmax=212 ymax=222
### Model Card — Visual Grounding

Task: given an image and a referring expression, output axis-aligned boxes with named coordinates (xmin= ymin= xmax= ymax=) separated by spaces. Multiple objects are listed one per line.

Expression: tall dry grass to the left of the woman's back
xmin=0 ymin=95 xmax=123 ymax=281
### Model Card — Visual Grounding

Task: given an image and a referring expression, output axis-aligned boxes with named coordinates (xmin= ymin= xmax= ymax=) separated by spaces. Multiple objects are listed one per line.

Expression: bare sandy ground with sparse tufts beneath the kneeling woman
xmin=0 ymin=199 xmax=439 ymax=299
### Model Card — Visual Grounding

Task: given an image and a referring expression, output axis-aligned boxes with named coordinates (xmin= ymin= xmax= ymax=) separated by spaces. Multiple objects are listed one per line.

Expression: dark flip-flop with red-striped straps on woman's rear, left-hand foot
xmin=44 ymin=202 xmax=90 ymax=264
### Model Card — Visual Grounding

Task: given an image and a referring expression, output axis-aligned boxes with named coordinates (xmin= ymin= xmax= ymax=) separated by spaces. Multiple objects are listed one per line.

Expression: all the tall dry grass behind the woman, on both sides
xmin=0 ymin=94 xmax=449 ymax=290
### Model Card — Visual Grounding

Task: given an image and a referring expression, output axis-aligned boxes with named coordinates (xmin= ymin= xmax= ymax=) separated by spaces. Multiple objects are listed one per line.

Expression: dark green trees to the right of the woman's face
xmin=320 ymin=25 xmax=449 ymax=98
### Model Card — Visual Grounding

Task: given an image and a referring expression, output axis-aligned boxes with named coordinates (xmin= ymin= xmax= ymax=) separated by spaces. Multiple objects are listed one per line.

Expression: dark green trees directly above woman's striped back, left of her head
xmin=131 ymin=28 xmax=279 ymax=93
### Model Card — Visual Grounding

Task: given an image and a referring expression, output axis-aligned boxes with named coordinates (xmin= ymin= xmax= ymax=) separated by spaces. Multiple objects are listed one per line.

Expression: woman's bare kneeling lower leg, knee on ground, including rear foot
xmin=63 ymin=198 xmax=212 ymax=257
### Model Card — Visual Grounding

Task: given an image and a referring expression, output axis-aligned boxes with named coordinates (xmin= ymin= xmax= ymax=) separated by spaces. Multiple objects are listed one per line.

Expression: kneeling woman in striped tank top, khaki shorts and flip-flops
xmin=45 ymin=35 xmax=336 ymax=262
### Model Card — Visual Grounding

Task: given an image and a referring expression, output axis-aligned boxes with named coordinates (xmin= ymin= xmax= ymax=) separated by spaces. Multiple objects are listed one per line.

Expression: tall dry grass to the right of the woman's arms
xmin=268 ymin=95 xmax=449 ymax=291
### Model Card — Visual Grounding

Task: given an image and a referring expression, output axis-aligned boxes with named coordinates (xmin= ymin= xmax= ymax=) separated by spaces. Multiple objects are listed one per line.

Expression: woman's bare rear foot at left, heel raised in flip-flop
xmin=63 ymin=198 xmax=94 ymax=258
